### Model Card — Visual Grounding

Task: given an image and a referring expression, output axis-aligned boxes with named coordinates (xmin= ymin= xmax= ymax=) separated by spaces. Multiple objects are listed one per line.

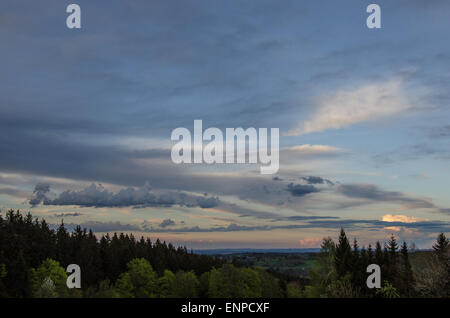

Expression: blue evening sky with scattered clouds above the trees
xmin=0 ymin=0 xmax=450 ymax=249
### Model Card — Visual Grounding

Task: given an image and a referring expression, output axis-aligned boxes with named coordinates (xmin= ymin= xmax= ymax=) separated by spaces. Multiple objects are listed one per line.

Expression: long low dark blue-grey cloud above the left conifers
xmin=29 ymin=183 xmax=220 ymax=208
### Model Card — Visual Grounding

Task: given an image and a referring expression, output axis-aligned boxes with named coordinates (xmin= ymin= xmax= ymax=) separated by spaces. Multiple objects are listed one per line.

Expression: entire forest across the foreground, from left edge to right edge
xmin=0 ymin=210 xmax=450 ymax=298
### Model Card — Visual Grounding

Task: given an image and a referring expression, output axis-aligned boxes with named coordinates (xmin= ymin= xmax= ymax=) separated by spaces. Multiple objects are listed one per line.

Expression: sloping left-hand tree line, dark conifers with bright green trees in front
xmin=0 ymin=210 xmax=284 ymax=298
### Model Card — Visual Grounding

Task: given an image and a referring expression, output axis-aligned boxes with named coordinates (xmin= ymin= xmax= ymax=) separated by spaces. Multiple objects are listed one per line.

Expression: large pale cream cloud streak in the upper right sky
xmin=286 ymin=80 xmax=411 ymax=136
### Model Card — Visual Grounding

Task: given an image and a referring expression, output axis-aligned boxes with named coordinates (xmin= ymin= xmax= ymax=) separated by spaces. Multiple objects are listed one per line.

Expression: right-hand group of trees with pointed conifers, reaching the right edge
xmin=296 ymin=229 xmax=450 ymax=298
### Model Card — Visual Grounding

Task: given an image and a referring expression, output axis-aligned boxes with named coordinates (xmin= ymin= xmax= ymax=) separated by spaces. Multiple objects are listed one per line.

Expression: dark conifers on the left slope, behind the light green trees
xmin=0 ymin=210 xmax=224 ymax=297
